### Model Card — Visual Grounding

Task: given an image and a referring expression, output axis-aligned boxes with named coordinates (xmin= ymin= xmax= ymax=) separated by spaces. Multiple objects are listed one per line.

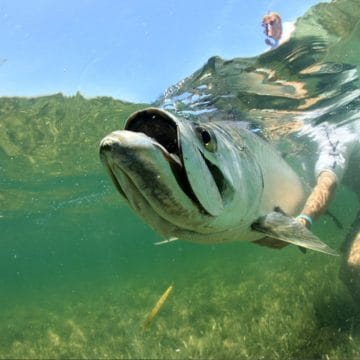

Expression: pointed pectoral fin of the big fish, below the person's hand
xmin=252 ymin=211 xmax=338 ymax=256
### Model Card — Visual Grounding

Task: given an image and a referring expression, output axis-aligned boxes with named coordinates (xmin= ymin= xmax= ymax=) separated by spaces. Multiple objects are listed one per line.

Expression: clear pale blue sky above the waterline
xmin=0 ymin=0 xmax=319 ymax=102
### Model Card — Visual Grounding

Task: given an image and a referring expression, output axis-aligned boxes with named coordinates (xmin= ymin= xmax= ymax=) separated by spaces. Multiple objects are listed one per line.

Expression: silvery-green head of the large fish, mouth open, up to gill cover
xmin=100 ymin=108 xmax=263 ymax=241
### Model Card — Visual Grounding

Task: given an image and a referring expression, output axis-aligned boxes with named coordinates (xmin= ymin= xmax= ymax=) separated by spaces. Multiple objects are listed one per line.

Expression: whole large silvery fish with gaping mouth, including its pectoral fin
xmin=100 ymin=108 xmax=335 ymax=254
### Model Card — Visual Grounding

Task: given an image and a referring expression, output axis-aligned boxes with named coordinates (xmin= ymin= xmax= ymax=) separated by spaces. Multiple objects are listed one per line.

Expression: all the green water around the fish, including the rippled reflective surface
xmin=0 ymin=0 xmax=360 ymax=359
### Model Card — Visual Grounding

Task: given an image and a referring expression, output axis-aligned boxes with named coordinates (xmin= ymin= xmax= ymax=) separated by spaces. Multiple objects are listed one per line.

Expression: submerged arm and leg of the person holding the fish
xmin=297 ymin=123 xmax=360 ymax=304
